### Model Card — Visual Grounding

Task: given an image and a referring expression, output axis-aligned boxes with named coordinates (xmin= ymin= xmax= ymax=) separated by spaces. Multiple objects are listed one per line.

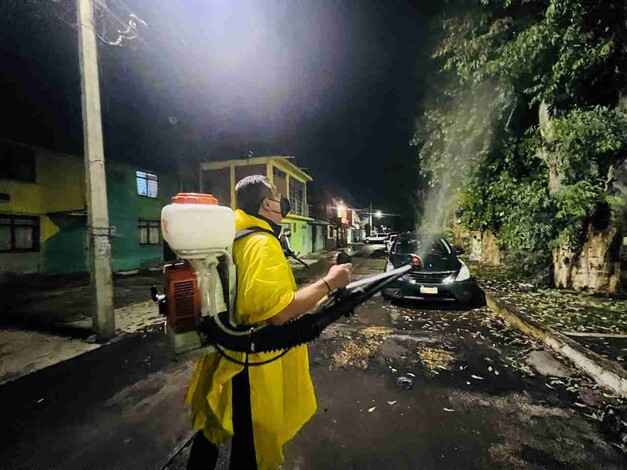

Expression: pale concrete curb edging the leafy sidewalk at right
xmin=484 ymin=291 xmax=627 ymax=398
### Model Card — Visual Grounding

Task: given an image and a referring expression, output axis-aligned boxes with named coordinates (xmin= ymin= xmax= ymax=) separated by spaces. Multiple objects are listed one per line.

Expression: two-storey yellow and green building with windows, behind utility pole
xmin=0 ymin=141 xmax=178 ymax=276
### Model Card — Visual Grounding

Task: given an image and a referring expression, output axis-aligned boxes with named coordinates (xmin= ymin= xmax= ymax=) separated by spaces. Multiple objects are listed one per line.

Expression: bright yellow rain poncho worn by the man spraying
xmin=186 ymin=210 xmax=316 ymax=469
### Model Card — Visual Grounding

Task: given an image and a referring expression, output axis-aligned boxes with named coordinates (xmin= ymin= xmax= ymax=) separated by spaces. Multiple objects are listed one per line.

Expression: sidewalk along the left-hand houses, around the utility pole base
xmin=0 ymin=249 xmax=354 ymax=385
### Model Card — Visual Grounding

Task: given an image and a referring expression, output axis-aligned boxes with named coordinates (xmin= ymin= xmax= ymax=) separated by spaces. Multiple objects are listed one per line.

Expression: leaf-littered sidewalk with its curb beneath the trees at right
xmin=469 ymin=263 xmax=627 ymax=397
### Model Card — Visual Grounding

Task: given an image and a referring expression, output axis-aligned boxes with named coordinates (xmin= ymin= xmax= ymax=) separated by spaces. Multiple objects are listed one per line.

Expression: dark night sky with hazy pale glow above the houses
xmin=0 ymin=0 xmax=442 ymax=220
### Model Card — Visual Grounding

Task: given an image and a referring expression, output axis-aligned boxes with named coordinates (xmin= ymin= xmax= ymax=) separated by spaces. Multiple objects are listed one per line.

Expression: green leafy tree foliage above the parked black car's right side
xmin=414 ymin=0 xmax=627 ymax=280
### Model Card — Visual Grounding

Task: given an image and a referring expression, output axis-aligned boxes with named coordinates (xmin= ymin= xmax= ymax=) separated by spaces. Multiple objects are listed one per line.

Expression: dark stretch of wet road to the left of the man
xmin=0 ymin=331 xmax=193 ymax=469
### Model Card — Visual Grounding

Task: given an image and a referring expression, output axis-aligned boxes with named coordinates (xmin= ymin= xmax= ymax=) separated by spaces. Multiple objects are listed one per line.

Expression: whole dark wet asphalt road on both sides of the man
xmin=0 ymin=244 xmax=625 ymax=469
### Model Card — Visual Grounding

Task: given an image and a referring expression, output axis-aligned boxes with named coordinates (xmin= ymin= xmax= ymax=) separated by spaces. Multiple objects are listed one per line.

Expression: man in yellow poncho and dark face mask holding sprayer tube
xmin=187 ymin=175 xmax=352 ymax=470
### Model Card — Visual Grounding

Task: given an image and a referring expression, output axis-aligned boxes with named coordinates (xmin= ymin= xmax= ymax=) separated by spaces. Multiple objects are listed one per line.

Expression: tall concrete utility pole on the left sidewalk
xmin=77 ymin=0 xmax=115 ymax=340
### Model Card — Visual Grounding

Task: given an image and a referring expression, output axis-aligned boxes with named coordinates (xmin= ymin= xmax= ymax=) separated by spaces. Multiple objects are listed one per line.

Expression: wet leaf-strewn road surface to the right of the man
xmin=286 ymin=248 xmax=626 ymax=469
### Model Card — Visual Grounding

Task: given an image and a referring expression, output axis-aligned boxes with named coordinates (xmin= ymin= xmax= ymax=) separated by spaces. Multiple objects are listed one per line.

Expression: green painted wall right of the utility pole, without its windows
xmin=107 ymin=161 xmax=178 ymax=272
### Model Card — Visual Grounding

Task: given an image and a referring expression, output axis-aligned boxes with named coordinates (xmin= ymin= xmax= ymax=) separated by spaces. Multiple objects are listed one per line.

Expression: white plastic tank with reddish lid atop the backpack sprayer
xmin=161 ymin=193 xmax=235 ymax=259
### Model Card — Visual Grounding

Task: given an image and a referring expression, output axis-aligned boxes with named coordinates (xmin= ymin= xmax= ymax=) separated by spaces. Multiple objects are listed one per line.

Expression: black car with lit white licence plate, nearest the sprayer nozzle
xmin=381 ymin=232 xmax=477 ymax=303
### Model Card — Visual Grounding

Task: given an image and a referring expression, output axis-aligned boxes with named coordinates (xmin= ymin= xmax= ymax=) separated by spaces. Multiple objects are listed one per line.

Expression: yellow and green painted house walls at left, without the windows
xmin=0 ymin=145 xmax=178 ymax=276
